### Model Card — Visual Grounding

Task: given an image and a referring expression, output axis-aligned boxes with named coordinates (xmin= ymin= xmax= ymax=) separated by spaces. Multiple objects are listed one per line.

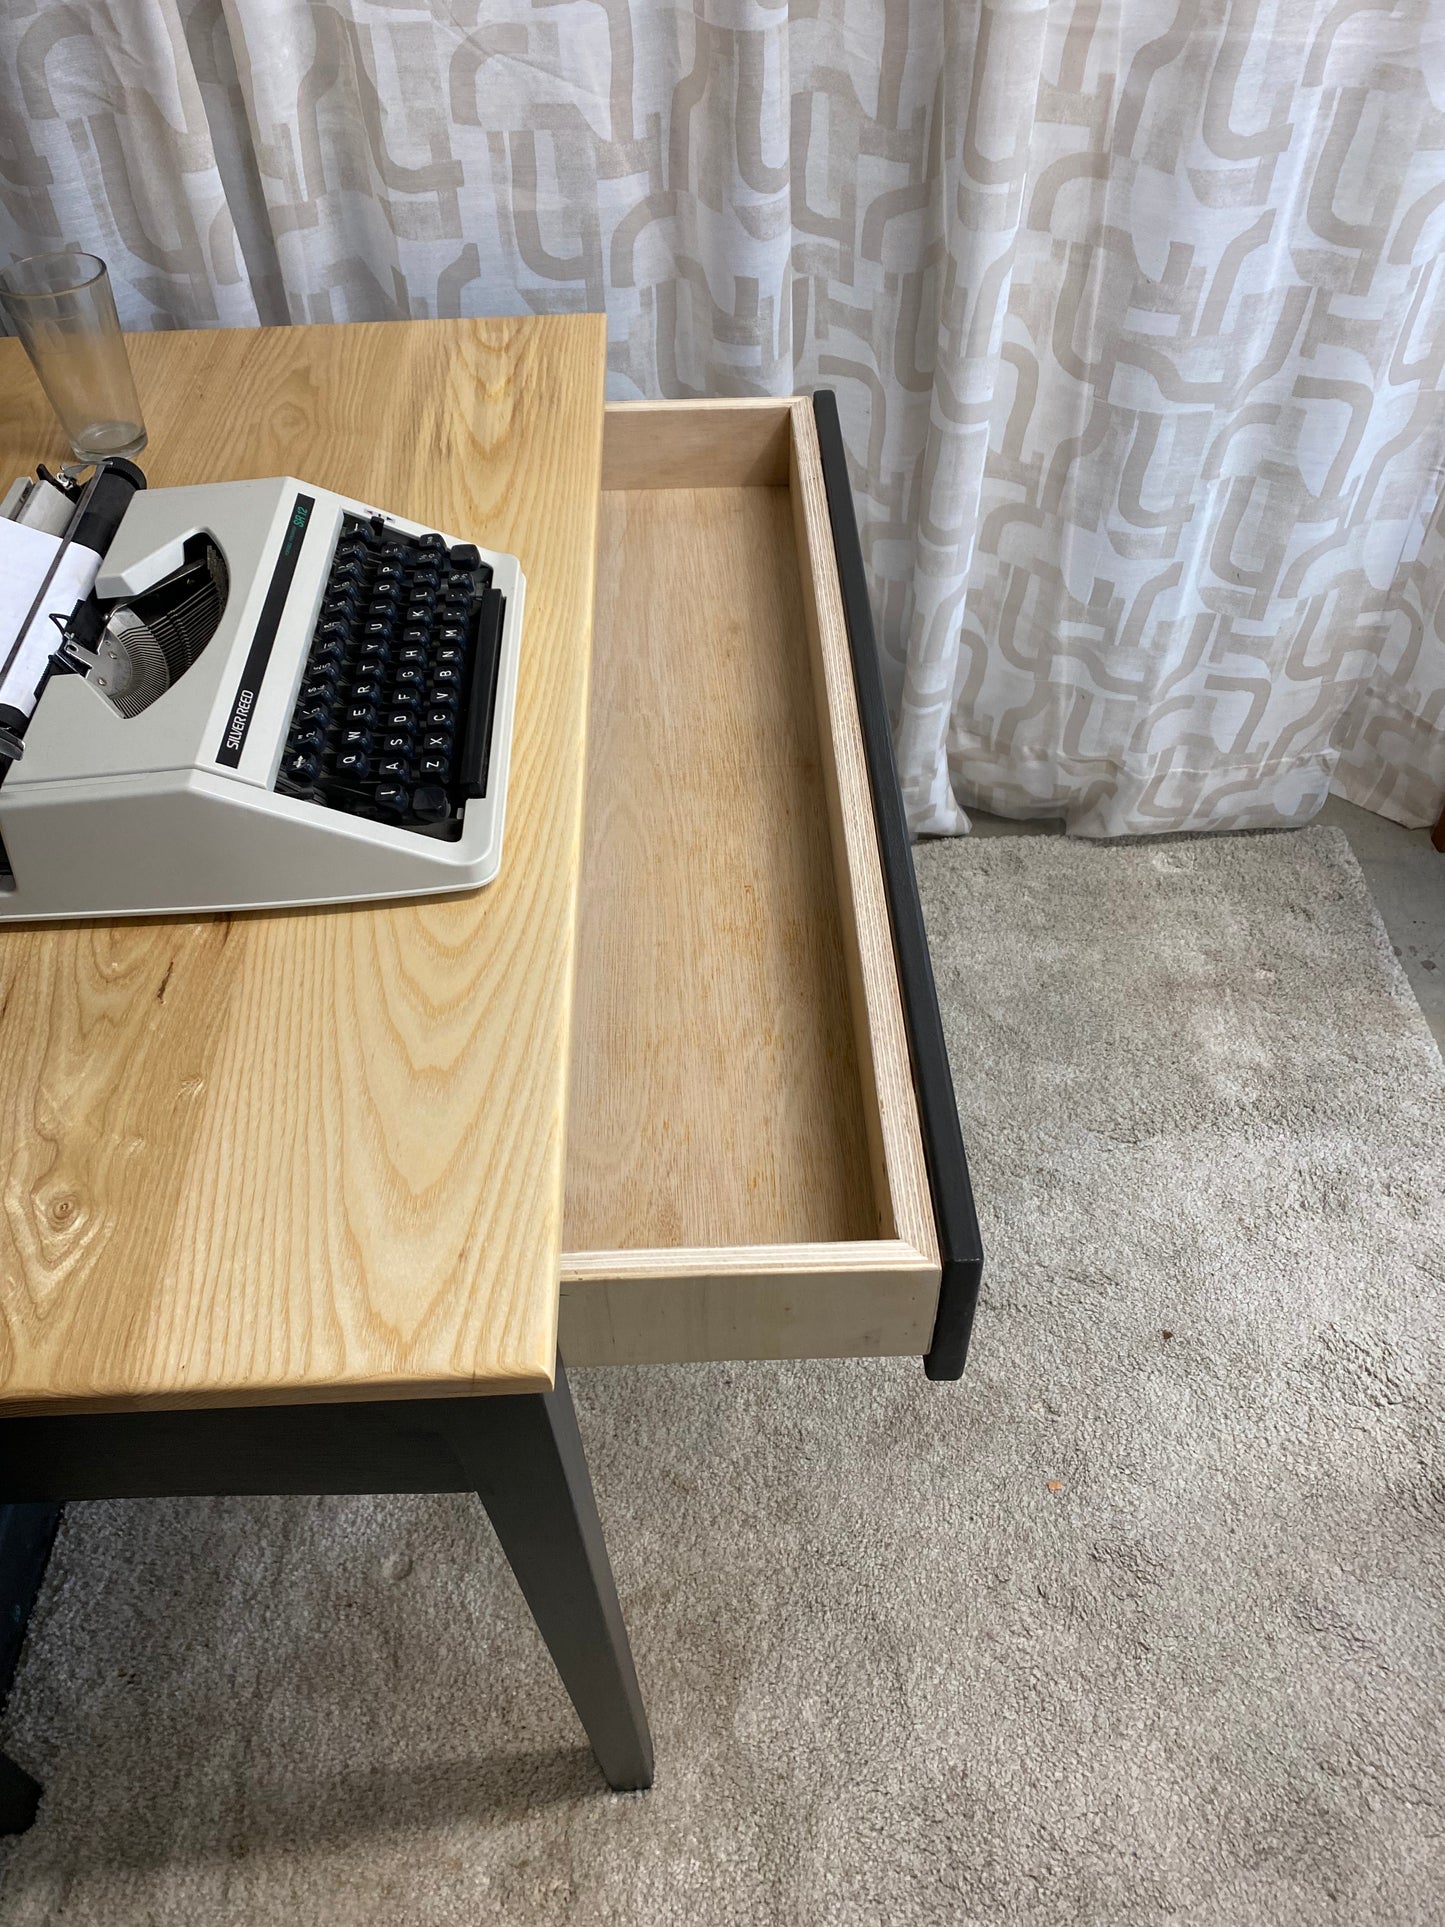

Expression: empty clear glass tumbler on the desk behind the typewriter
xmin=0 ymin=249 xmax=146 ymax=462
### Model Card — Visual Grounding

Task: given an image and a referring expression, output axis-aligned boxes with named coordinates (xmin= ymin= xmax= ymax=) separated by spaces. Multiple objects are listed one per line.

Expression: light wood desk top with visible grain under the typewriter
xmin=0 ymin=316 xmax=605 ymax=1412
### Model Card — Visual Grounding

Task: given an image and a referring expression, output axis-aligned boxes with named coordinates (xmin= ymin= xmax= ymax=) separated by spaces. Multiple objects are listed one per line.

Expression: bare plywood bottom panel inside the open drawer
xmin=565 ymin=488 xmax=879 ymax=1251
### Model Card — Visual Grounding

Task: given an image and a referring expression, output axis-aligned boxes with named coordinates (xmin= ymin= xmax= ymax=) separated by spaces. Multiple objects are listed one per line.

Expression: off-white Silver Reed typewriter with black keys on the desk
xmin=0 ymin=461 xmax=526 ymax=921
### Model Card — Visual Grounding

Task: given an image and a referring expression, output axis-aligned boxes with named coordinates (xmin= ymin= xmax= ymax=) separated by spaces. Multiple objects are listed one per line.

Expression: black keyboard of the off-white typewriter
xmin=277 ymin=515 xmax=505 ymax=836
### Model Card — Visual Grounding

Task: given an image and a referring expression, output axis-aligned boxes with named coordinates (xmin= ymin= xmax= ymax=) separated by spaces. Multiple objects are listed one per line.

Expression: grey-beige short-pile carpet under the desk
xmin=0 ymin=831 xmax=1445 ymax=1927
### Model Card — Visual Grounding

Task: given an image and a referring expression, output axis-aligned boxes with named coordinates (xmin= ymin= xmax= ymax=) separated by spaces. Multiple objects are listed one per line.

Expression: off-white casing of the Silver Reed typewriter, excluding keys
xmin=0 ymin=476 xmax=526 ymax=921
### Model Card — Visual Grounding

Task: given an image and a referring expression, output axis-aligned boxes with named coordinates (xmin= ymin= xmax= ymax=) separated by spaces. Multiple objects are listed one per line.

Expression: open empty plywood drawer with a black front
xmin=559 ymin=395 xmax=979 ymax=1376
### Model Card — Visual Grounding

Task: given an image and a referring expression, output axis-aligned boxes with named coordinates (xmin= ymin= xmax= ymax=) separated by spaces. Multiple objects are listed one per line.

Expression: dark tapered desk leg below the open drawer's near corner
xmin=445 ymin=1359 xmax=653 ymax=1792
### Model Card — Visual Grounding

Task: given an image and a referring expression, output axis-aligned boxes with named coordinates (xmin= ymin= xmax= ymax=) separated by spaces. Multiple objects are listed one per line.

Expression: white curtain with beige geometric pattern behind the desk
xmin=0 ymin=0 xmax=1445 ymax=836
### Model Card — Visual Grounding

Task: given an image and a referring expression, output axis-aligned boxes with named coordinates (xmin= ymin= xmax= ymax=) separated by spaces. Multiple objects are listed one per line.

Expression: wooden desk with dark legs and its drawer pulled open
xmin=0 ymin=318 xmax=981 ymax=1819
